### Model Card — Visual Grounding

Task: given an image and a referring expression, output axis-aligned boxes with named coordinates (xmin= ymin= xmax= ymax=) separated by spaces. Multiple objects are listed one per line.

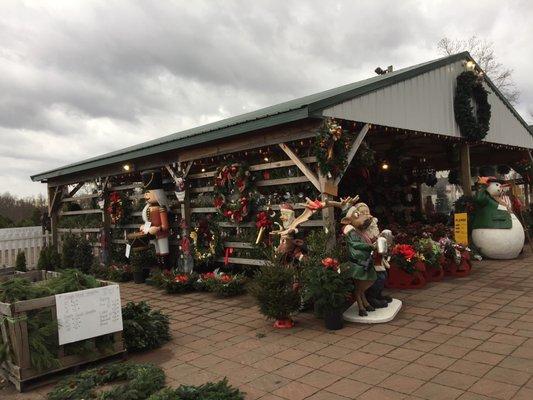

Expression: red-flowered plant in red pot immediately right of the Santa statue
xmin=386 ymin=244 xmax=426 ymax=289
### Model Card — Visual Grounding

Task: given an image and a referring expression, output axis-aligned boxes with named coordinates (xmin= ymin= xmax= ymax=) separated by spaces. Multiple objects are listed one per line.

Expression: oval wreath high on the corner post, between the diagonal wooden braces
xmin=315 ymin=118 xmax=350 ymax=178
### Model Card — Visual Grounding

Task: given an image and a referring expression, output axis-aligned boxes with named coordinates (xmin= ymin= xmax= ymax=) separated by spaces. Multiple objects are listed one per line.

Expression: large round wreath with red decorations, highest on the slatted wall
xmin=214 ymin=163 xmax=251 ymax=223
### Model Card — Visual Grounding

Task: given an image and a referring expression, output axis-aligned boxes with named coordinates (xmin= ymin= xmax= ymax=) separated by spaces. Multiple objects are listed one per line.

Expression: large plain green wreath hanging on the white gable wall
xmin=453 ymin=71 xmax=491 ymax=141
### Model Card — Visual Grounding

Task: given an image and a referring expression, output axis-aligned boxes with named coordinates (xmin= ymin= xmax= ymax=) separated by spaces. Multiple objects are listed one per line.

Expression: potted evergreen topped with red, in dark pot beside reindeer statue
xmin=304 ymin=257 xmax=354 ymax=330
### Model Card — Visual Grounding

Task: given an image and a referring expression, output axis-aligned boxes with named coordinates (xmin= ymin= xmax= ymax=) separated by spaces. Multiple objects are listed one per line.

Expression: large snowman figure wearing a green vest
xmin=472 ymin=177 xmax=524 ymax=260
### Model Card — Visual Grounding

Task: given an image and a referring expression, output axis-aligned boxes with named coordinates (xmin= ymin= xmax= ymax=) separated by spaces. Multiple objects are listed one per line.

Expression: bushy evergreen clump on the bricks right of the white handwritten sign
xmin=122 ymin=301 xmax=171 ymax=352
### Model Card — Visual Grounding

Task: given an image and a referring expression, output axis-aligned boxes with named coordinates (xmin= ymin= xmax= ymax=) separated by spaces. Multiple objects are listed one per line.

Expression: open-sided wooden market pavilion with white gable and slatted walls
xmin=32 ymin=52 xmax=533 ymax=272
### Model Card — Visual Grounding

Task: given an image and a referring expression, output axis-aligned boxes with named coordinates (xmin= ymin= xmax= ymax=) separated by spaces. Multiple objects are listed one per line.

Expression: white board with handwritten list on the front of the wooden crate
xmin=55 ymin=285 xmax=122 ymax=345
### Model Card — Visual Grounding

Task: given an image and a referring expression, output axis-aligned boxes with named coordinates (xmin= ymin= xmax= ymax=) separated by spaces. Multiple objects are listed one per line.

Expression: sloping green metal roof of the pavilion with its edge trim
xmin=31 ymin=52 xmax=527 ymax=181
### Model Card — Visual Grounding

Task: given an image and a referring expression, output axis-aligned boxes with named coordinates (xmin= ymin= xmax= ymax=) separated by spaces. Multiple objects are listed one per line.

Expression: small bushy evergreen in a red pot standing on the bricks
xmin=249 ymin=259 xmax=301 ymax=329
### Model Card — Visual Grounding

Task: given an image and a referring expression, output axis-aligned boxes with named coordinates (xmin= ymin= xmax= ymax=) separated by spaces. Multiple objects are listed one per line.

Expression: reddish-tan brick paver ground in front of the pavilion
xmin=0 ymin=252 xmax=533 ymax=400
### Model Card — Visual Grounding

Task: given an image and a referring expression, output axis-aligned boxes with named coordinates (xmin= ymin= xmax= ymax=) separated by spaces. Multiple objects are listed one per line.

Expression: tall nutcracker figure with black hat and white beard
xmin=140 ymin=170 xmax=169 ymax=268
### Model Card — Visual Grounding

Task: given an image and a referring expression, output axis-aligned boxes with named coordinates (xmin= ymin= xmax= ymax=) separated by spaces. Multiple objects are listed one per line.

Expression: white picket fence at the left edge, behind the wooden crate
xmin=0 ymin=226 xmax=51 ymax=269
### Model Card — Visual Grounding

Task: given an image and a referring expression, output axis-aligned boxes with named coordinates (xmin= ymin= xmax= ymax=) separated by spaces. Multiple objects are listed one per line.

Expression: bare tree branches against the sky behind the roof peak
xmin=437 ymin=35 xmax=520 ymax=104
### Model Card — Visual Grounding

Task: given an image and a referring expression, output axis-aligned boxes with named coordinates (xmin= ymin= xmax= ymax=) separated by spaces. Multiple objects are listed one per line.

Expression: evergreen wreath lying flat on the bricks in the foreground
xmin=48 ymin=363 xmax=165 ymax=400
